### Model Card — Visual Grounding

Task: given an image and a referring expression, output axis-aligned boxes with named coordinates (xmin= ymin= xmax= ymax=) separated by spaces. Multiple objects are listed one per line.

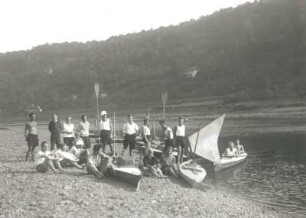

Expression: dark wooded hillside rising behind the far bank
xmin=0 ymin=0 xmax=306 ymax=116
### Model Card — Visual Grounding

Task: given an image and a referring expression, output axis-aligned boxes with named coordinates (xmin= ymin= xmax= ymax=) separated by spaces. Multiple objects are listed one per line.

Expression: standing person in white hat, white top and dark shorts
xmin=99 ymin=111 xmax=114 ymax=155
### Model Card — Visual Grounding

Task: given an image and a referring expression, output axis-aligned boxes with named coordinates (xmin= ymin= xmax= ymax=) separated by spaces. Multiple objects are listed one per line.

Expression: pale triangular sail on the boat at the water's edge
xmin=189 ymin=114 xmax=225 ymax=163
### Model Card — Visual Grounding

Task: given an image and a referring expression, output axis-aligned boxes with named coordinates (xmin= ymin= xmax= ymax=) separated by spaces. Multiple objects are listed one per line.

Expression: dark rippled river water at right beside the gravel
xmin=214 ymin=135 xmax=306 ymax=216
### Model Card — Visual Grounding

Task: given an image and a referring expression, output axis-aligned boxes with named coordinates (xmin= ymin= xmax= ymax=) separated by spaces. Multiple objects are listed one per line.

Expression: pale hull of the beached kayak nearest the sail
xmin=179 ymin=163 xmax=206 ymax=187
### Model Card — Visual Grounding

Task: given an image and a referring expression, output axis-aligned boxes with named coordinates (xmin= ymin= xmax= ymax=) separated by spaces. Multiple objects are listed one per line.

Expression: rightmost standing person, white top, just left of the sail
xmin=174 ymin=117 xmax=186 ymax=163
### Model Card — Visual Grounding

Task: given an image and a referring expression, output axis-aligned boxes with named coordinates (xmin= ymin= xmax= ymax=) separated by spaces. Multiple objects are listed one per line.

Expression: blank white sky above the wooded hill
xmin=0 ymin=0 xmax=253 ymax=53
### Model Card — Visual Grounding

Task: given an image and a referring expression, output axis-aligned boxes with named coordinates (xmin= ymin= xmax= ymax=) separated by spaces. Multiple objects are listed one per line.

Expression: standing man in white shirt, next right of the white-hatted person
xmin=123 ymin=115 xmax=139 ymax=156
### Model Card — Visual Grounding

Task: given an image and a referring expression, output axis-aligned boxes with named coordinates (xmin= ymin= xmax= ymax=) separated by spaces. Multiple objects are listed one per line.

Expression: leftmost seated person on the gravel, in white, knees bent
xmin=36 ymin=141 xmax=64 ymax=173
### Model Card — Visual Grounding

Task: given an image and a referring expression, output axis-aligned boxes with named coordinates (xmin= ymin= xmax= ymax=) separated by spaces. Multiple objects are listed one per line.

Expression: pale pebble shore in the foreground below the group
xmin=0 ymin=127 xmax=289 ymax=217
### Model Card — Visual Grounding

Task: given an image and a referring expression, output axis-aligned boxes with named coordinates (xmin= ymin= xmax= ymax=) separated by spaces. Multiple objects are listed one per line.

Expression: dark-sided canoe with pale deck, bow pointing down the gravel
xmin=113 ymin=167 xmax=142 ymax=189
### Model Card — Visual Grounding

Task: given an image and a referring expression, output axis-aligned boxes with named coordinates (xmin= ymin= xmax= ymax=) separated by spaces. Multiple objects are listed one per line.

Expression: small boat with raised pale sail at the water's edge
xmin=189 ymin=114 xmax=248 ymax=172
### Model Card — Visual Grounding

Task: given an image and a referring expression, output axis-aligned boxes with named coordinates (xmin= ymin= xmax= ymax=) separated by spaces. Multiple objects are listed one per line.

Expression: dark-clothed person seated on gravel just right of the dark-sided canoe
xmin=143 ymin=148 xmax=167 ymax=178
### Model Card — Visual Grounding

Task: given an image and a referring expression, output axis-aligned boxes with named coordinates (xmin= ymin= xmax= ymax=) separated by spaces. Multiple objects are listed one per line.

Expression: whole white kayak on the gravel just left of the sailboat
xmin=179 ymin=160 xmax=206 ymax=187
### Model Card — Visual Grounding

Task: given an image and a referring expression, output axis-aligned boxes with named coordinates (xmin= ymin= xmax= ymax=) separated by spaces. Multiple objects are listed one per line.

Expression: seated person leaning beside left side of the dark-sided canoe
xmin=86 ymin=144 xmax=112 ymax=179
